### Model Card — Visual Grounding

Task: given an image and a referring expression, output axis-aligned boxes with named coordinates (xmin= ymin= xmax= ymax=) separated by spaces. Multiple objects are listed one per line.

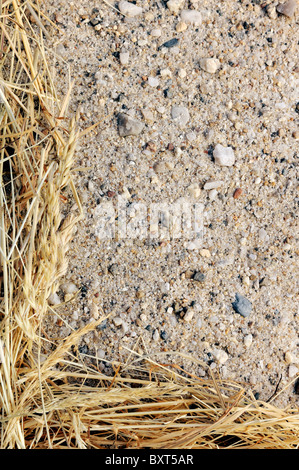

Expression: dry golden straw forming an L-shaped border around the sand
xmin=0 ymin=0 xmax=299 ymax=449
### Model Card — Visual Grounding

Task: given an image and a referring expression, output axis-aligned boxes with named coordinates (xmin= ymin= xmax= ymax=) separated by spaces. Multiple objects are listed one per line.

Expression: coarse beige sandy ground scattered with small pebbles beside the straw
xmin=41 ymin=0 xmax=299 ymax=406
